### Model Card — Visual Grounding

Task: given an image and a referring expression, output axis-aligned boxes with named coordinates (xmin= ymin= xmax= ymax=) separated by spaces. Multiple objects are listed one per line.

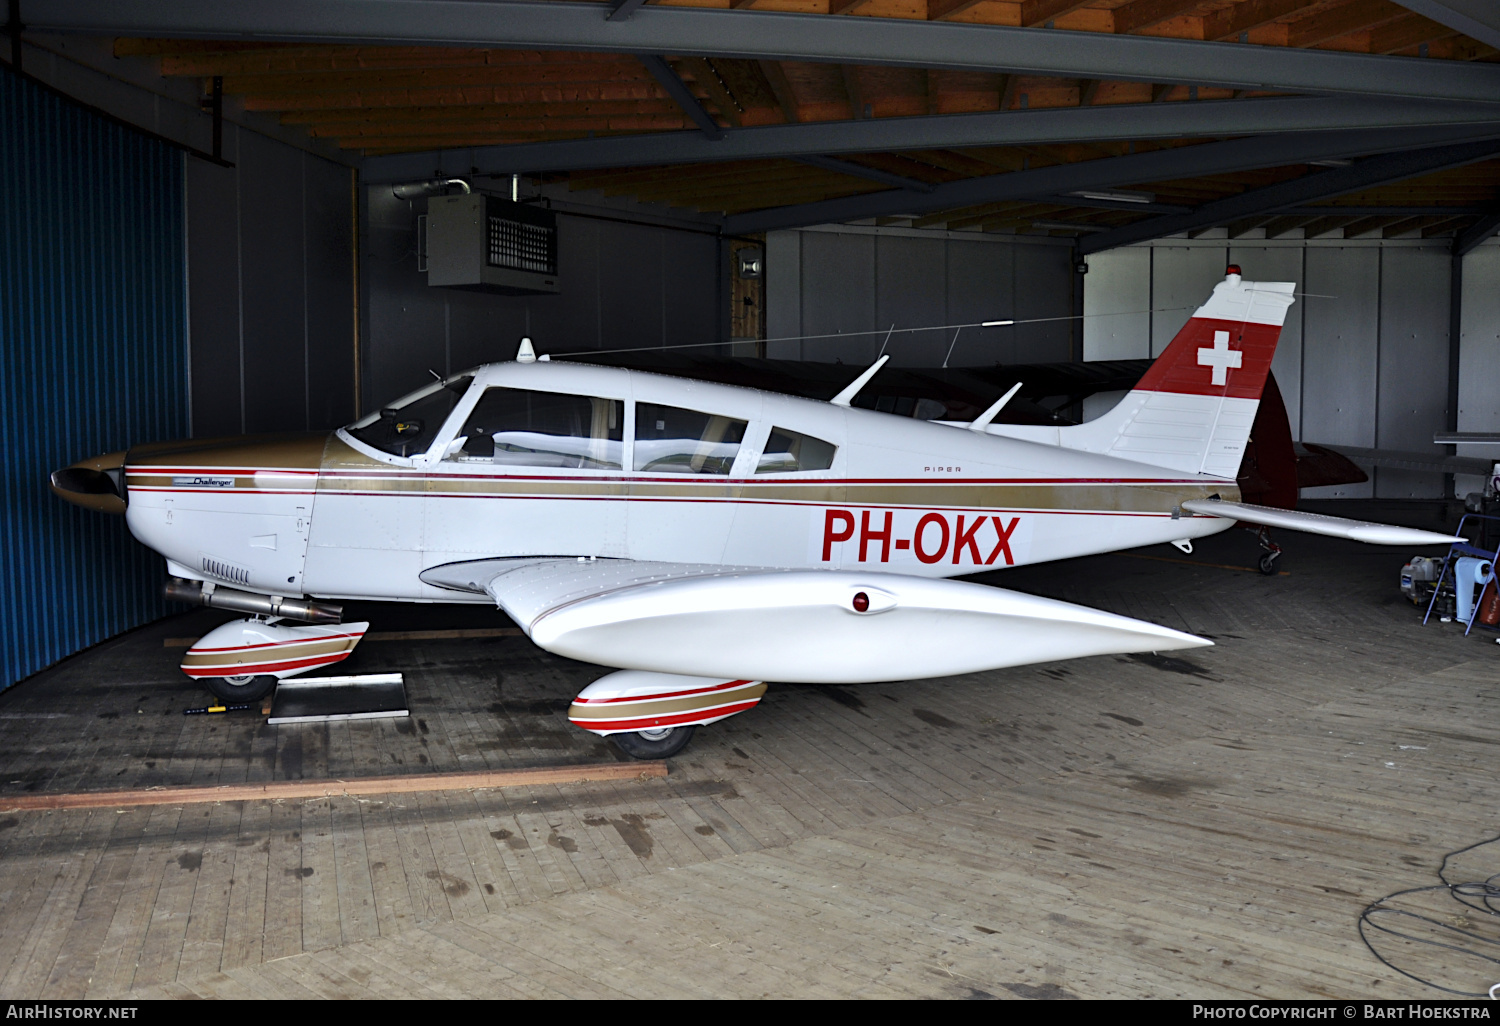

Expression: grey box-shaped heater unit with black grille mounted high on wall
xmin=426 ymin=192 xmax=561 ymax=296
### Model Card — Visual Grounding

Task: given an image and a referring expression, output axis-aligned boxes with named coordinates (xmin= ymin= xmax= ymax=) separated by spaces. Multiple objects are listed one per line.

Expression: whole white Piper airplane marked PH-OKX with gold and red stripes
xmin=53 ymin=267 xmax=1451 ymax=758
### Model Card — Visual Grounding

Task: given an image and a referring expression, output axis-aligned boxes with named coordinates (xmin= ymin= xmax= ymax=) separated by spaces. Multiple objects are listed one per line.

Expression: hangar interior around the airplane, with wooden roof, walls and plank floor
xmin=0 ymin=0 xmax=1500 ymax=999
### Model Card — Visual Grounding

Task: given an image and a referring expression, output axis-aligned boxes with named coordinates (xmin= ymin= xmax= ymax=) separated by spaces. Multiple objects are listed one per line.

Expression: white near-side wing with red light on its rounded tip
xmin=422 ymin=558 xmax=1212 ymax=684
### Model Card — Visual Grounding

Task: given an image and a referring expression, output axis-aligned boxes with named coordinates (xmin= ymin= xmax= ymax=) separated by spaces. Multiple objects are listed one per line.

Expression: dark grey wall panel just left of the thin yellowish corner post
xmin=302 ymin=155 xmax=354 ymax=429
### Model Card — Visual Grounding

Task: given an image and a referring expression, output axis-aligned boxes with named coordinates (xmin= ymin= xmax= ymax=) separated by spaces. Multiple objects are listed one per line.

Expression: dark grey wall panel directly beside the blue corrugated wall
xmin=186 ymin=126 xmax=245 ymax=438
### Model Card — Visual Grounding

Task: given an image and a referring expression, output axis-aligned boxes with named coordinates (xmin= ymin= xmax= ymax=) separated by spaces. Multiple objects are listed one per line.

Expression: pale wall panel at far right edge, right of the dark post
xmin=1454 ymin=243 xmax=1500 ymax=495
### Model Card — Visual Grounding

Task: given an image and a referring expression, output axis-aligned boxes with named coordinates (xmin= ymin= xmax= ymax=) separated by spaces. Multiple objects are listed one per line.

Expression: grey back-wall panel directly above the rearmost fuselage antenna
xmin=929 ymin=239 xmax=1026 ymax=368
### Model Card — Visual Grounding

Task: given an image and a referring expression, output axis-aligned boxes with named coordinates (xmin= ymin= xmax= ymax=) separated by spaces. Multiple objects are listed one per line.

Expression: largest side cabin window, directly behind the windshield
xmin=452 ymin=389 xmax=626 ymax=470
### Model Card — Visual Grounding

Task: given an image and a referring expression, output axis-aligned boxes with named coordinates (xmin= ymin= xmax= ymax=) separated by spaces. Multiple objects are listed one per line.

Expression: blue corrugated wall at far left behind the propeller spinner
xmin=0 ymin=74 xmax=188 ymax=687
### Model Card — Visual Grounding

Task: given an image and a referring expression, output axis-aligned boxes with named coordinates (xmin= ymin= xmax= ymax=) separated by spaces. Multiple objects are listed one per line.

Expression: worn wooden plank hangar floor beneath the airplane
xmin=0 ymin=503 xmax=1500 ymax=998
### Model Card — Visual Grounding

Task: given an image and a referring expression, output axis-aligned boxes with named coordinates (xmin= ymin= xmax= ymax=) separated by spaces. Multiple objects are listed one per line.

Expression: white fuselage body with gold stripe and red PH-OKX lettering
xmin=128 ymin=362 xmax=1238 ymax=602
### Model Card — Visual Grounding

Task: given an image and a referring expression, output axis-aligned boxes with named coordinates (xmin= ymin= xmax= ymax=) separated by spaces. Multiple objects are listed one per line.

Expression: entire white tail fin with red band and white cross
xmin=1062 ymin=266 xmax=1295 ymax=479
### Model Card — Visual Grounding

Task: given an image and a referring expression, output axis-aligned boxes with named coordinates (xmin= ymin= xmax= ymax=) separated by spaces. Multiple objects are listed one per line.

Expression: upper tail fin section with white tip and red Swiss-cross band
xmin=1136 ymin=266 xmax=1292 ymax=399
